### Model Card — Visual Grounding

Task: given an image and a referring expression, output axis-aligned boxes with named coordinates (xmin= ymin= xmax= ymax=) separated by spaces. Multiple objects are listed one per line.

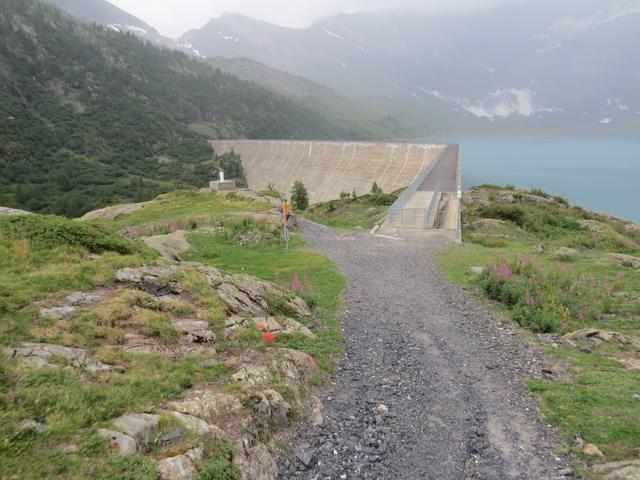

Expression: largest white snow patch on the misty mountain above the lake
xmin=418 ymin=87 xmax=559 ymax=120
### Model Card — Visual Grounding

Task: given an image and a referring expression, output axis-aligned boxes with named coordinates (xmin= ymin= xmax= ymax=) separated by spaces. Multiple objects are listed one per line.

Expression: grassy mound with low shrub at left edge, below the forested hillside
xmin=0 ymin=216 xmax=156 ymax=345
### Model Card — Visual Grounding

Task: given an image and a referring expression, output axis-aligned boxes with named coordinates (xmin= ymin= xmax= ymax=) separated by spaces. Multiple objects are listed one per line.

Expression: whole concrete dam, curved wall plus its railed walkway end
xmin=210 ymin=140 xmax=462 ymax=236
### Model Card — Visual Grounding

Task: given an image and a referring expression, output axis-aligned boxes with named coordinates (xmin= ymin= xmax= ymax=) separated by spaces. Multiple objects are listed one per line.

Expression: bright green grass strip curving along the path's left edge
xmin=185 ymin=233 xmax=346 ymax=371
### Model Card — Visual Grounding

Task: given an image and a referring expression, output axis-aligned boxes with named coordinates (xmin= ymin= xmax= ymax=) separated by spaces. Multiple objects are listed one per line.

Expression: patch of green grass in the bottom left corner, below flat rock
xmin=0 ymin=349 xmax=229 ymax=478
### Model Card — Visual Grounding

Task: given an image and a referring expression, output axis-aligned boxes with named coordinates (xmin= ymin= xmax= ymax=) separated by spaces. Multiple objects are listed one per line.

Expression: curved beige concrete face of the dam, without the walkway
xmin=210 ymin=140 xmax=445 ymax=203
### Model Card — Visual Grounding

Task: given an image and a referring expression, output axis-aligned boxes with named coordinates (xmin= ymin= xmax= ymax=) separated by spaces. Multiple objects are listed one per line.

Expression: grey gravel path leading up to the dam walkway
xmin=280 ymin=222 xmax=567 ymax=480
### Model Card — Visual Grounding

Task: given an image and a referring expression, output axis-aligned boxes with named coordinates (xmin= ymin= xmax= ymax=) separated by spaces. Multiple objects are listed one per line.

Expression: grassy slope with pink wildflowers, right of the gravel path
xmin=441 ymin=188 xmax=640 ymax=470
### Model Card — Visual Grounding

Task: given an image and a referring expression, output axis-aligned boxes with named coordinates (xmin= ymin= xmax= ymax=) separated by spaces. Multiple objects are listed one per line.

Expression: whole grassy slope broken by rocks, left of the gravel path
xmin=0 ymin=192 xmax=344 ymax=479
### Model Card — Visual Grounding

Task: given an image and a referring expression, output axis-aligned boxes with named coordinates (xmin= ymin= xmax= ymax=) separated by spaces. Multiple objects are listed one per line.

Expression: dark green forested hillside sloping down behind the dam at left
xmin=0 ymin=0 xmax=366 ymax=216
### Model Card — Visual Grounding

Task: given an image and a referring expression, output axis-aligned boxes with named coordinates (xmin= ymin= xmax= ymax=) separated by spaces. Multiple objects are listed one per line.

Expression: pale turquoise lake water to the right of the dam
xmin=440 ymin=138 xmax=640 ymax=223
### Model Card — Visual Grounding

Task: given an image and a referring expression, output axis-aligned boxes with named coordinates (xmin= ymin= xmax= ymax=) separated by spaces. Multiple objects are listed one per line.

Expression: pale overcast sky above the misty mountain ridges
xmin=109 ymin=0 xmax=548 ymax=38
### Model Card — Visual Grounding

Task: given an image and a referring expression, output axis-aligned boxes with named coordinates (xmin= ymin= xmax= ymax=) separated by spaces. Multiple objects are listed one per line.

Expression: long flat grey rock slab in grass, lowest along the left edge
xmin=5 ymin=342 xmax=121 ymax=373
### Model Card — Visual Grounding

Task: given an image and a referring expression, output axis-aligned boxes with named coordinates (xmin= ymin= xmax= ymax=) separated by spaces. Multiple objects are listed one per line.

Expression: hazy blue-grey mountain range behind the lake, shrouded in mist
xmin=180 ymin=2 xmax=640 ymax=134
